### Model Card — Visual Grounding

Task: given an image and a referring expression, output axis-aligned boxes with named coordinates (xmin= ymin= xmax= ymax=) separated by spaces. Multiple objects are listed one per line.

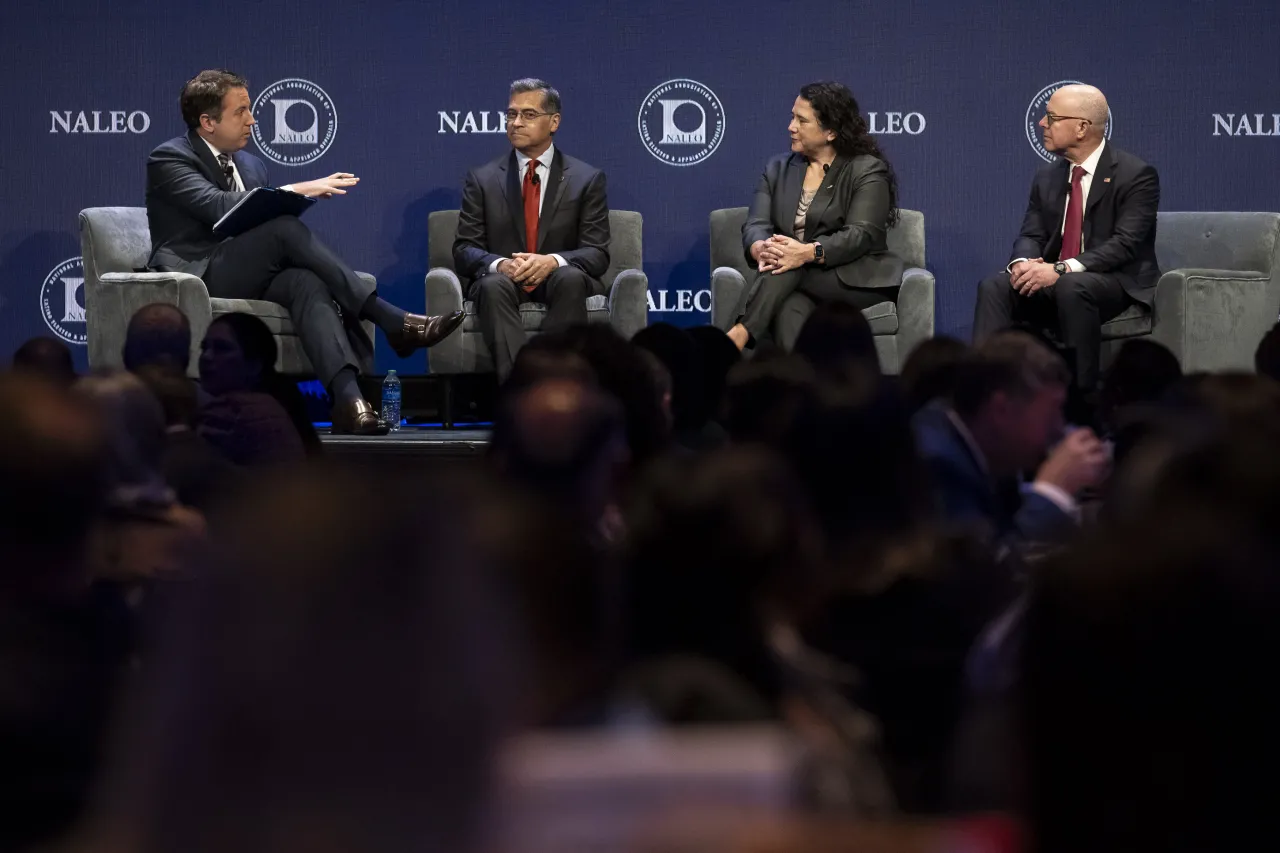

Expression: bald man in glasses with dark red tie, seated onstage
xmin=973 ymin=85 xmax=1160 ymax=396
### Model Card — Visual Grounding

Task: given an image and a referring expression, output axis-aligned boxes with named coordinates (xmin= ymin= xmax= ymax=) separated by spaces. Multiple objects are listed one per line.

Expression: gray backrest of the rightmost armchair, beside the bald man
xmin=1156 ymin=211 xmax=1280 ymax=279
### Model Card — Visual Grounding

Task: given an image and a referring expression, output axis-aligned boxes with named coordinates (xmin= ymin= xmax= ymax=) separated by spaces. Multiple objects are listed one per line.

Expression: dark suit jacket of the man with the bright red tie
xmin=453 ymin=147 xmax=609 ymax=286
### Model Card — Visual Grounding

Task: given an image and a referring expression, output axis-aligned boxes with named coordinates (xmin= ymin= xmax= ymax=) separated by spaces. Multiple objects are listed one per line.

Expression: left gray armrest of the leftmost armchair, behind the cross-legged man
xmin=84 ymin=273 xmax=212 ymax=373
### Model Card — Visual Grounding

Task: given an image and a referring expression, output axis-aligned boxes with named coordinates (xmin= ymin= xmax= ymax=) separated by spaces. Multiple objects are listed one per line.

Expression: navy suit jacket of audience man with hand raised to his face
xmin=911 ymin=403 xmax=1076 ymax=544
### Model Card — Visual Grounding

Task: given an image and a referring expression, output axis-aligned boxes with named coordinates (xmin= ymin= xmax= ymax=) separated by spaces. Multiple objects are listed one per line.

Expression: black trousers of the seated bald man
xmin=973 ymin=273 xmax=1133 ymax=393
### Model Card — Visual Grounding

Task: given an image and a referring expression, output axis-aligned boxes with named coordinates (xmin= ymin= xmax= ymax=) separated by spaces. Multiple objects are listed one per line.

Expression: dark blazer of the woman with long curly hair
xmin=742 ymin=154 xmax=902 ymax=287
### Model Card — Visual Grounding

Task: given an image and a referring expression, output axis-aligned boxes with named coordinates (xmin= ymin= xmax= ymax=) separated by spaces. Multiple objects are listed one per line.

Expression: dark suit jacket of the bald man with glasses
xmin=1010 ymin=142 xmax=1160 ymax=305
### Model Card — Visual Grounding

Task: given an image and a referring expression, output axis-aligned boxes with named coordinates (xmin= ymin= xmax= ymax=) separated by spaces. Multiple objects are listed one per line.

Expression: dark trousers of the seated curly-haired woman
xmin=741 ymin=266 xmax=893 ymax=351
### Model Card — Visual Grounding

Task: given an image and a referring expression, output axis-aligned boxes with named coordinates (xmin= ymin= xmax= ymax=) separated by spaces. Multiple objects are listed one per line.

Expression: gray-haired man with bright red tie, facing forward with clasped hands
xmin=453 ymin=79 xmax=609 ymax=379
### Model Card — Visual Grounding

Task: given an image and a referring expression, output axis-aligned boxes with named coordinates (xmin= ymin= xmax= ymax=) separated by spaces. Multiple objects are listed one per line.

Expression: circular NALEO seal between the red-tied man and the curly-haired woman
xmin=636 ymin=79 xmax=724 ymax=167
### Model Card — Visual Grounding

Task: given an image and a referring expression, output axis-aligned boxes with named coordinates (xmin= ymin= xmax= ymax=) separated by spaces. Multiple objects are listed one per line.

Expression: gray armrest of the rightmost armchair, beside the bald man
xmin=1151 ymin=269 xmax=1277 ymax=373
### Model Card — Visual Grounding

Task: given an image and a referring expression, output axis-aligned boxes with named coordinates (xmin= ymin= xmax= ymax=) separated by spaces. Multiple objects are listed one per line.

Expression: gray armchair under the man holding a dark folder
xmin=79 ymin=207 xmax=374 ymax=377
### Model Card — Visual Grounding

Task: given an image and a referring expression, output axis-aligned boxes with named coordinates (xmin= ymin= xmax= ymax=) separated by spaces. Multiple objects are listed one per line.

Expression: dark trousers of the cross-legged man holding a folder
xmin=205 ymin=216 xmax=374 ymax=387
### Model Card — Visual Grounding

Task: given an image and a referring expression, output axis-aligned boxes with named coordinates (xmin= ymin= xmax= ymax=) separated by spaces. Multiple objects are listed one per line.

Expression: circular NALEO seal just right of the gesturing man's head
xmin=253 ymin=77 xmax=338 ymax=165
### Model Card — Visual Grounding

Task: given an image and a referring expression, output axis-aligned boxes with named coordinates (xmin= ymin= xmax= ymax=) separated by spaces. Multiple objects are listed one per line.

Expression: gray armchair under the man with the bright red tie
xmin=426 ymin=210 xmax=649 ymax=375
